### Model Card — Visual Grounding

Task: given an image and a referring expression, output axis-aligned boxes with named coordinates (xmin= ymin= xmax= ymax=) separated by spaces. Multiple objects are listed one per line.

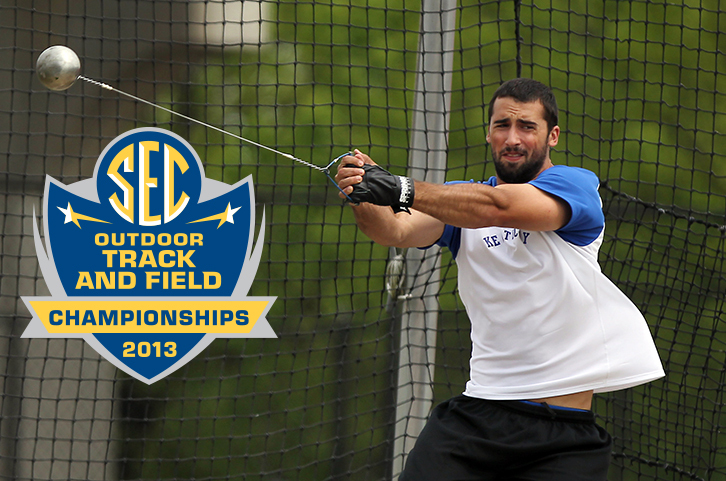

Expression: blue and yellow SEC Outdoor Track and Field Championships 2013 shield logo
xmin=23 ymin=128 xmax=276 ymax=383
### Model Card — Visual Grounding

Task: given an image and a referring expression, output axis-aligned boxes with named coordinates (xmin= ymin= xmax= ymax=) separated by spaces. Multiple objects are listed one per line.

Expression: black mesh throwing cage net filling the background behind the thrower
xmin=0 ymin=0 xmax=726 ymax=480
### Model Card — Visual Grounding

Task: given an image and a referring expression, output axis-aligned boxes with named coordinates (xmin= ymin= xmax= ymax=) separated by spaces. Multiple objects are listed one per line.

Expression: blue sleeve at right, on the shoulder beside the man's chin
xmin=529 ymin=165 xmax=605 ymax=246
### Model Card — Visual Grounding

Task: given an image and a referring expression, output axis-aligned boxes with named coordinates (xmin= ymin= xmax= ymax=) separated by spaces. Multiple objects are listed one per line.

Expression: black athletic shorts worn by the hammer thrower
xmin=399 ymin=395 xmax=612 ymax=481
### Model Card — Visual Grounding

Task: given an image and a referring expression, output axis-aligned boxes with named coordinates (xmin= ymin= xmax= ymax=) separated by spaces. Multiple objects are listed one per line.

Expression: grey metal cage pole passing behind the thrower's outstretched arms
xmin=392 ymin=0 xmax=457 ymax=472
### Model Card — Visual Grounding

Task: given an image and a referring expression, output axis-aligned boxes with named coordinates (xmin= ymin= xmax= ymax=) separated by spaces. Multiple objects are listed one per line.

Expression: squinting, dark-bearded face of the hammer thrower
xmin=487 ymin=97 xmax=560 ymax=184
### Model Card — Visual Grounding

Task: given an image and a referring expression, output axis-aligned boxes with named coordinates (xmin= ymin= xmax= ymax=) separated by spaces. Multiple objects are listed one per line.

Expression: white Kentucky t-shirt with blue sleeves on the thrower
xmin=438 ymin=166 xmax=664 ymax=400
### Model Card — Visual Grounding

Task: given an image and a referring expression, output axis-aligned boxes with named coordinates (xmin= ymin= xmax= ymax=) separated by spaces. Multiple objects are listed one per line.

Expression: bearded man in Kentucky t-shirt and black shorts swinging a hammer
xmin=336 ymin=79 xmax=664 ymax=481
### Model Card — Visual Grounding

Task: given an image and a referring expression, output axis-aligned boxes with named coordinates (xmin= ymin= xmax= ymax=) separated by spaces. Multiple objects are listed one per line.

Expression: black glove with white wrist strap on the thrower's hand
xmin=348 ymin=164 xmax=414 ymax=214
